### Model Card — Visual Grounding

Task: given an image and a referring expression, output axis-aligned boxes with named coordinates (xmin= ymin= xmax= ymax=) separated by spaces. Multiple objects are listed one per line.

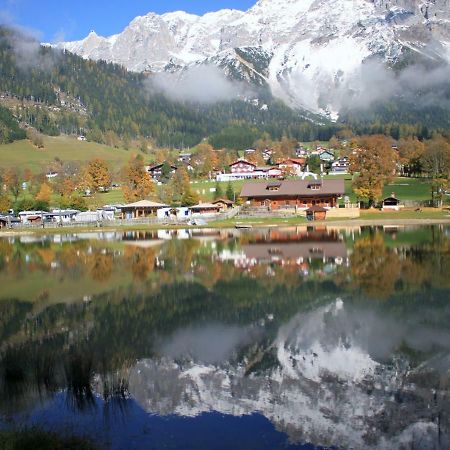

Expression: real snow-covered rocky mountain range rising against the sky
xmin=58 ymin=0 xmax=450 ymax=118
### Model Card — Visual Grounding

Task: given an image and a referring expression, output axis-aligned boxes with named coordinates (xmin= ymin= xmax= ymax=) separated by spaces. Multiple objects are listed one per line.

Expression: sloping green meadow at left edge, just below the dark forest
xmin=0 ymin=136 xmax=148 ymax=173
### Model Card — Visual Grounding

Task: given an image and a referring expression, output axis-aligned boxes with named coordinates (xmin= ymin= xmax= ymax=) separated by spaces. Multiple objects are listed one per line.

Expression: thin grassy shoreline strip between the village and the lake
xmin=0 ymin=216 xmax=450 ymax=238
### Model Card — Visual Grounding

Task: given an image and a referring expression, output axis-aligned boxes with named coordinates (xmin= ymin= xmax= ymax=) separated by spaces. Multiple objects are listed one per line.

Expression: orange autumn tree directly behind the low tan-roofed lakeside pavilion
xmin=122 ymin=155 xmax=155 ymax=202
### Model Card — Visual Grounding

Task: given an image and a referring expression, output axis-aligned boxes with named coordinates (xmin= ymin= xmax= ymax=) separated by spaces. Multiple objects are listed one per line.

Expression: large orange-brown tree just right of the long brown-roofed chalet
xmin=350 ymin=135 xmax=397 ymax=206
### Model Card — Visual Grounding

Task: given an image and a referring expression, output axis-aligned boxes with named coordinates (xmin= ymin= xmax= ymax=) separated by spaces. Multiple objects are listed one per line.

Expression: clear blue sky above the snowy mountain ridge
xmin=0 ymin=0 xmax=256 ymax=42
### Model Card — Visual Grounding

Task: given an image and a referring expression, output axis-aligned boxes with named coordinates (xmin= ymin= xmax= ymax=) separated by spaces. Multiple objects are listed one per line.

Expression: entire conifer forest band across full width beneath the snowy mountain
xmin=0 ymin=27 xmax=448 ymax=149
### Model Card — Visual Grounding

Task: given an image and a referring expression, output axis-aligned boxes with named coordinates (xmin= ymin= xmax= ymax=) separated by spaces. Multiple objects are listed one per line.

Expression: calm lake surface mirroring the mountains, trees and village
xmin=0 ymin=226 xmax=450 ymax=449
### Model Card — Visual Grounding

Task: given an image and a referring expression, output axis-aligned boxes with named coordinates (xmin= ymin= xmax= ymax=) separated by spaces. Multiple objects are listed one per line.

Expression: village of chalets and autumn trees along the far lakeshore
xmin=0 ymin=136 xmax=448 ymax=228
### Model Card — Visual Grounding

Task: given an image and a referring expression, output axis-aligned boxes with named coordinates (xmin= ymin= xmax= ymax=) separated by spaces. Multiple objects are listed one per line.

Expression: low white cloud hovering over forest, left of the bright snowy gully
xmin=146 ymin=65 xmax=244 ymax=104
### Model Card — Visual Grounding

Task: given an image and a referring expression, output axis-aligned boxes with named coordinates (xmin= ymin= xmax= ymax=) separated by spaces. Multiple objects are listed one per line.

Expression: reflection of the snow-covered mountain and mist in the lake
xmin=124 ymin=298 xmax=450 ymax=449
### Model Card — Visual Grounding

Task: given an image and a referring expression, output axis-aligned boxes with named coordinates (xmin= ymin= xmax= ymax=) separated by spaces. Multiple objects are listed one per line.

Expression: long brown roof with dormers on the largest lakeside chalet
xmin=241 ymin=180 xmax=345 ymax=198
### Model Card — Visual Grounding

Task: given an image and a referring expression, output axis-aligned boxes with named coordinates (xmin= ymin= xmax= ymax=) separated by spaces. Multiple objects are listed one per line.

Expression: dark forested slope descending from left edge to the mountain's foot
xmin=0 ymin=28 xmax=337 ymax=148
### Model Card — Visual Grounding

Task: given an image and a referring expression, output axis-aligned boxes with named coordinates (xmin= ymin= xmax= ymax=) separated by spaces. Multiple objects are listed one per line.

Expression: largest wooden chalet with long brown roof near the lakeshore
xmin=240 ymin=180 xmax=345 ymax=209
